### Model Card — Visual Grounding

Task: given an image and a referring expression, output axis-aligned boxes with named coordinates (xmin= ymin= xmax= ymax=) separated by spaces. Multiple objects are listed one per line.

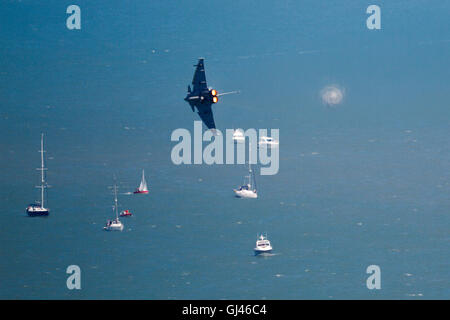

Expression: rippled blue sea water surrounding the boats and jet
xmin=0 ymin=1 xmax=450 ymax=299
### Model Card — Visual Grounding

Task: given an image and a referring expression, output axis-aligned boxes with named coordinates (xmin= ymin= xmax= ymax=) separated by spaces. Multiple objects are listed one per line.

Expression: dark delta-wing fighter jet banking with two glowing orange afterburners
xmin=184 ymin=58 xmax=238 ymax=131
